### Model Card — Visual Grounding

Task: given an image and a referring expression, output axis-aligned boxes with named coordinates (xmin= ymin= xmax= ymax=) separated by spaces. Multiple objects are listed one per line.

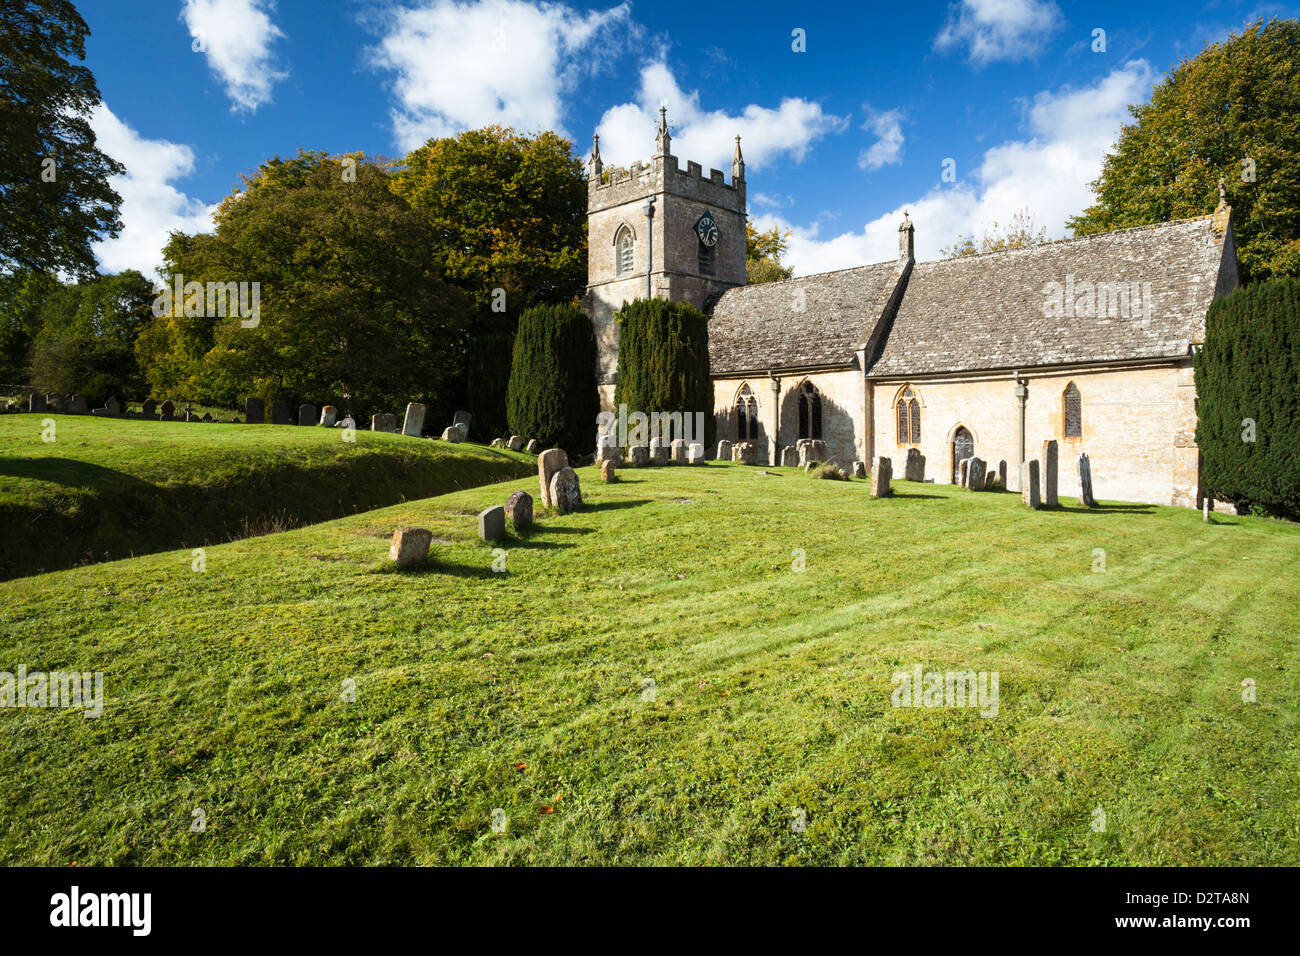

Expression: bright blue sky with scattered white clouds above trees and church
xmin=77 ymin=0 xmax=1300 ymax=274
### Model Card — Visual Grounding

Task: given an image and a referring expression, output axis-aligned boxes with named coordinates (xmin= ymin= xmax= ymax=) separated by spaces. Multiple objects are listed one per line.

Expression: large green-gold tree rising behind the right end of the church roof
xmin=1069 ymin=20 xmax=1300 ymax=282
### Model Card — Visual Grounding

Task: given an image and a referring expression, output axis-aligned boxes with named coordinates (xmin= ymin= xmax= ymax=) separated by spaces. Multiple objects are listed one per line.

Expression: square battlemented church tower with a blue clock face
xmin=582 ymin=108 xmax=745 ymax=410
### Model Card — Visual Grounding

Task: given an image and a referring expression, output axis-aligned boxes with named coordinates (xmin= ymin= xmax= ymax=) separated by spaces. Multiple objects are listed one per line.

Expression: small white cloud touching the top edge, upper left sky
xmin=181 ymin=0 xmax=287 ymax=113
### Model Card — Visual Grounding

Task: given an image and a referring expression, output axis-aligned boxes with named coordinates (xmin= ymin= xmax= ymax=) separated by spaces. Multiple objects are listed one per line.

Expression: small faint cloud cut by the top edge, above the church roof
xmin=935 ymin=0 xmax=1062 ymax=65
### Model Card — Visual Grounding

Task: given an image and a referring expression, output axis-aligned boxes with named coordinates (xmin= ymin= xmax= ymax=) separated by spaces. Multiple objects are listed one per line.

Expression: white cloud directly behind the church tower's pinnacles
xmin=597 ymin=61 xmax=849 ymax=170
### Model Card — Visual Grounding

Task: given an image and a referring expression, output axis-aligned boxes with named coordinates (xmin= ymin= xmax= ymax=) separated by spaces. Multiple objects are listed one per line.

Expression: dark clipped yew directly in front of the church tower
xmin=614 ymin=299 xmax=716 ymax=446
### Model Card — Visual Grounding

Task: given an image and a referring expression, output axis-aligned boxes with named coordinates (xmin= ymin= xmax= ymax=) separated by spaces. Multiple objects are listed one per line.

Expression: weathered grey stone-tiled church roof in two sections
xmin=709 ymin=216 xmax=1223 ymax=377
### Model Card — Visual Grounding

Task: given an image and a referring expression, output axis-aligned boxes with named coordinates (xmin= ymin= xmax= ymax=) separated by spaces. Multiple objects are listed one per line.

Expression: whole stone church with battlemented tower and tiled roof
xmin=584 ymin=109 xmax=1239 ymax=506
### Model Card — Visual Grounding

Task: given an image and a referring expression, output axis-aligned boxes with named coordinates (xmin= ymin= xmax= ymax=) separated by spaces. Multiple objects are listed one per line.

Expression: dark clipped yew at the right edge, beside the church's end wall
xmin=1196 ymin=278 xmax=1300 ymax=519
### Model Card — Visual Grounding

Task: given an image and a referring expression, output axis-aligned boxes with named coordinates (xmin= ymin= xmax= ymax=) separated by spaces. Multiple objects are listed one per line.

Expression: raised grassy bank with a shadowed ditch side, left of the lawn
xmin=0 ymin=415 xmax=536 ymax=579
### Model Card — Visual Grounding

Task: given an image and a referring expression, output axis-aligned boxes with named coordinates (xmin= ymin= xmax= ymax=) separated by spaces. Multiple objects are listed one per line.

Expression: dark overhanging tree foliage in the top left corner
xmin=0 ymin=0 xmax=125 ymax=277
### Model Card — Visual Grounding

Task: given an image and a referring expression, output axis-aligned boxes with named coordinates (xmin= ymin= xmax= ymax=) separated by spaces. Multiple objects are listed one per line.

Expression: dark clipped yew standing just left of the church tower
xmin=506 ymin=306 xmax=601 ymax=455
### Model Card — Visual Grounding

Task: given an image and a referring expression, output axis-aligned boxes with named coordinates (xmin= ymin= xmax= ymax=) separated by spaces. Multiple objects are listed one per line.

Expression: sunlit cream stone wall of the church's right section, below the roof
xmin=868 ymin=359 xmax=1199 ymax=506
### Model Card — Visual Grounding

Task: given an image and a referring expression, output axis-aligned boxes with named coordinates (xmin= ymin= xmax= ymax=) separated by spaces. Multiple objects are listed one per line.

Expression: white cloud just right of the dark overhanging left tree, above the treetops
xmin=90 ymin=104 xmax=217 ymax=277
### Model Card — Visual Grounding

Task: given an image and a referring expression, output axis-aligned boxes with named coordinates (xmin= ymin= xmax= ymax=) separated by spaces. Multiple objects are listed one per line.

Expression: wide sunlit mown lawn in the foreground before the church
xmin=0 ymin=464 xmax=1300 ymax=865
